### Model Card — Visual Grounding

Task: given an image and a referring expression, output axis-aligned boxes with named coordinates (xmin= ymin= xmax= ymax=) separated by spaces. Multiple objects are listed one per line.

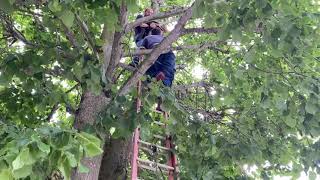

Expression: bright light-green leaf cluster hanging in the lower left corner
xmin=0 ymin=122 xmax=102 ymax=179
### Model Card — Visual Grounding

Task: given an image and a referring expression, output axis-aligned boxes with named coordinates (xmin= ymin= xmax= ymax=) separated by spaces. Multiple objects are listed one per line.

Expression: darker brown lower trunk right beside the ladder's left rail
xmin=99 ymin=138 xmax=132 ymax=180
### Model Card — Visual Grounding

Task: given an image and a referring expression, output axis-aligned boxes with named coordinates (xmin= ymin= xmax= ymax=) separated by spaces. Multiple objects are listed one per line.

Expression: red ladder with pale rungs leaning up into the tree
xmin=131 ymin=81 xmax=178 ymax=180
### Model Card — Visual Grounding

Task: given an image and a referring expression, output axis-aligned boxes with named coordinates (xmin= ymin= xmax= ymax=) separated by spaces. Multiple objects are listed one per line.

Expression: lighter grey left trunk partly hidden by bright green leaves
xmin=72 ymin=92 xmax=110 ymax=180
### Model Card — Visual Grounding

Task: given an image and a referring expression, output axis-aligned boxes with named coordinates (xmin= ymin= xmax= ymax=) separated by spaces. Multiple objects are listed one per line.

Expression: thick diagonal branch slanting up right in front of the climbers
xmin=118 ymin=4 xmax=194 ymax=95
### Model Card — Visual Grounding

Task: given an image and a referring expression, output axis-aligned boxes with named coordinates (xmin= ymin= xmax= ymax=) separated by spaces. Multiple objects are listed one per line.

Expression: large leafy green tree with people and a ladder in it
xmin=0 ymin=0 xmax=320 ymax=179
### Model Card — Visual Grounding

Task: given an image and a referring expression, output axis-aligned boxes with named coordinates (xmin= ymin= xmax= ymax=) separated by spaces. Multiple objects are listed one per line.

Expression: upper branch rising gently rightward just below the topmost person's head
xmin=124 ymin=8 xmax=188 ymax=33
